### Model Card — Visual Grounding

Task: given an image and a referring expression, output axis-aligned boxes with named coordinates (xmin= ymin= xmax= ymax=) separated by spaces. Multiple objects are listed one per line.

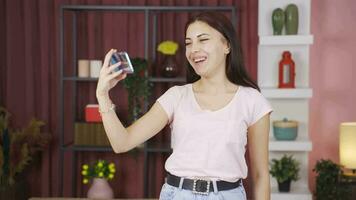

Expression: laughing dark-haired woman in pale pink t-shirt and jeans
xmin=97 ymin=12 xmax=272 ymax=200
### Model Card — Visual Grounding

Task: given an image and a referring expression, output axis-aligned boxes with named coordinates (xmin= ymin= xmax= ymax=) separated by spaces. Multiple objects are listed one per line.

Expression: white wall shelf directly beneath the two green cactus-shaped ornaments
xmin=260 ymin=35 xmax=314 ymax=45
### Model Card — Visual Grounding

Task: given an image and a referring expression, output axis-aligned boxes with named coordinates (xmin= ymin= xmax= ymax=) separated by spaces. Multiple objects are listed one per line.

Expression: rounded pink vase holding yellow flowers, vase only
xmin=87 ymin=178 xmax=114 ymax=199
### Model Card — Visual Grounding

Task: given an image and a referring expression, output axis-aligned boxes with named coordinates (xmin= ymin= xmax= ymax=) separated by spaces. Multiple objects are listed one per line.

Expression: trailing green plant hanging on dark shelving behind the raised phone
xmin=123 ymin=58 xmax=151 ymax=122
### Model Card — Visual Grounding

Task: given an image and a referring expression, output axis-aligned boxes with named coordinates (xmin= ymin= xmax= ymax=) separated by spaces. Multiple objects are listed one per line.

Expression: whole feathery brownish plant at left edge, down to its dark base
xmin=0 ymin=107 xmax=51 ymax=199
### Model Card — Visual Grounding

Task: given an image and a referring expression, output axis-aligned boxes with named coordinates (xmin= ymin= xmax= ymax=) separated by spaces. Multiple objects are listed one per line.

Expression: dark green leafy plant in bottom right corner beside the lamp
xmin=313 ymin=159 xmax=350 ymax=200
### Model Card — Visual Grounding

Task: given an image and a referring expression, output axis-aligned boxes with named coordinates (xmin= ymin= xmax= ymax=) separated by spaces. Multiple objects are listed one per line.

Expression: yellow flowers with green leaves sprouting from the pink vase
xmin=82 ymin=160 xmax=116 ymax=184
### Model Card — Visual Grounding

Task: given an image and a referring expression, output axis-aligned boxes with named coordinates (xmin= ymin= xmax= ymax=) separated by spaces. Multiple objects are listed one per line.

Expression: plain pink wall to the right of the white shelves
xmin=309 ymin=0 xmax=356 ymax=191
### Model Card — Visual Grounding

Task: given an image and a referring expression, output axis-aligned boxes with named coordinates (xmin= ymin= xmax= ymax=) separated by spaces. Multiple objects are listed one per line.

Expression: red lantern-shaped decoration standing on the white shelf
xmin=278 ymin=51 xmax=295 ymax=88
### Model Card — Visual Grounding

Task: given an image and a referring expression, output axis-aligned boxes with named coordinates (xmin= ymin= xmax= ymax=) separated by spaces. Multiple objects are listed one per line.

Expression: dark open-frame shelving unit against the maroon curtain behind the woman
xmin=58 ymin=5 xmax=236 ymax=198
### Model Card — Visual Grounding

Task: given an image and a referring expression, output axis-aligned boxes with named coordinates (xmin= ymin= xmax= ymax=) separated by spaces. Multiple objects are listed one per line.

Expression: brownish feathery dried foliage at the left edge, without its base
xmin=0 ymin=107 xmax=51 ymax=186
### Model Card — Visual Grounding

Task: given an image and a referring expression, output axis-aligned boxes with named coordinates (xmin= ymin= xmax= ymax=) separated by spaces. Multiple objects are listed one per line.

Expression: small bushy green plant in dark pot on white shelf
xmin=270 ymin=155 xmax=300 ymax=192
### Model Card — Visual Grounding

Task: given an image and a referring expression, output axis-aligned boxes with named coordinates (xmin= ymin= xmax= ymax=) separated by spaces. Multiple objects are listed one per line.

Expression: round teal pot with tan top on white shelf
xmin=273 ymin=118 xmax=298 ymax=140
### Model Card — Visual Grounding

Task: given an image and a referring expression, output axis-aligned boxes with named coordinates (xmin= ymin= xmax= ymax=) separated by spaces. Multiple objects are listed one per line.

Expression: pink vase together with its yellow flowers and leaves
xmin=82 ymin=160 xmax=116 ymax=199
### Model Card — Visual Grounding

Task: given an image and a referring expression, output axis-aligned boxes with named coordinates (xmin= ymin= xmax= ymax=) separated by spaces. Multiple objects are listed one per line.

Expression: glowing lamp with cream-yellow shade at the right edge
xmin=340 ymin=122 xmax=356 ymax=176
